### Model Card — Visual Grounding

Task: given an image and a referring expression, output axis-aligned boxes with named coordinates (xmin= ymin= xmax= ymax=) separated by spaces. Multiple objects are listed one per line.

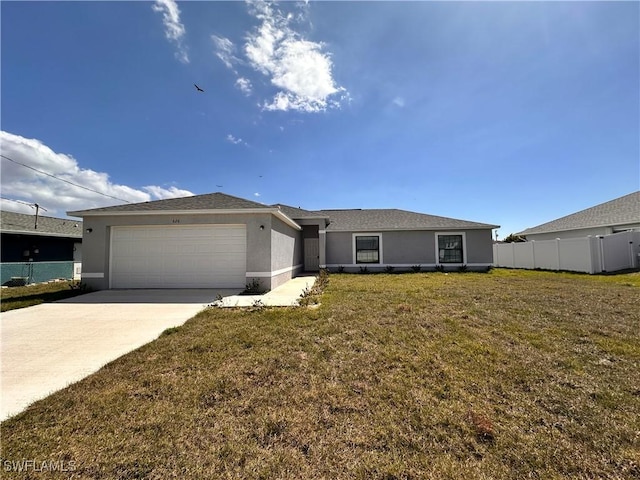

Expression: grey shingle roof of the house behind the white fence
xmin=518 ymin=191 xmax=640 ymax=235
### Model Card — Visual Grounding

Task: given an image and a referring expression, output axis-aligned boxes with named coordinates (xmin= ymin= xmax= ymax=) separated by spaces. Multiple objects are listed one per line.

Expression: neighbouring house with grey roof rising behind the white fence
xmin=517 ymin=191 xmax=640 ymax=241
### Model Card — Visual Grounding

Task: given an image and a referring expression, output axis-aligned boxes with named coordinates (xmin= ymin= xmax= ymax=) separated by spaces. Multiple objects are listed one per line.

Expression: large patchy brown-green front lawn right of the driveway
xmin=1 ymin=270 xmax=640 ymax=479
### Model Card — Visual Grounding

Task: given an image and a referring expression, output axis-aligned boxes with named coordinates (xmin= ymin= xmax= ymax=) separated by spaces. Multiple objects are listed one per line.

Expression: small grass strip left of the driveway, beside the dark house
xmin=0 ymin=282 xmax=86 ymax=312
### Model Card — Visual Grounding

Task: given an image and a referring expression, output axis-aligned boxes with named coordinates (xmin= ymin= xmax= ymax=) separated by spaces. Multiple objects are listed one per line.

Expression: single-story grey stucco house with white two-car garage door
xmin=68 ymin=193 xmax=498 ymax=289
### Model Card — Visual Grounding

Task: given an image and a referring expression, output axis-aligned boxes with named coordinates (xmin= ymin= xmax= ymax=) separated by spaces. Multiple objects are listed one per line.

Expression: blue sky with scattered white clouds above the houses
xmin=0 ymin=0 xmax=640 ymax=238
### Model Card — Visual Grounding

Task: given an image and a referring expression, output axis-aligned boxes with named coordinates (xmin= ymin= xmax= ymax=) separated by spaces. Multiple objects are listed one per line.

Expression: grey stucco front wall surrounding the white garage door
xmin=82 ymin=213 xmax=274 ymax=290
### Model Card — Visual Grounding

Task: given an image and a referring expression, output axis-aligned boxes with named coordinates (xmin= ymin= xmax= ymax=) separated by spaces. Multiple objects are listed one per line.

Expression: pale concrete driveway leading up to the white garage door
xmin=0 ymin=290 xmax=232 ymax=420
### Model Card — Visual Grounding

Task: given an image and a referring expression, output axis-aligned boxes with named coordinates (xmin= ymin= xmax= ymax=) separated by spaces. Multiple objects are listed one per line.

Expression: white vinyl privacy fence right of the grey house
xmin=493 ymin=231 xmax=640 ymax=273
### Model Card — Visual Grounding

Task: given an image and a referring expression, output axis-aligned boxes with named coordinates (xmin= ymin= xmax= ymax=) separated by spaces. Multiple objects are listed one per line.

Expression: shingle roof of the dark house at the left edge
xmin=0 ymin=211 xmax=82 ymax=238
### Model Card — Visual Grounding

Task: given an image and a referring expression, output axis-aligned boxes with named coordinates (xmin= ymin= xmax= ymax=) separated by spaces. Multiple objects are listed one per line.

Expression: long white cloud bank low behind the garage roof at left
xmin=0 ymin=131 xmax=193 ymax=216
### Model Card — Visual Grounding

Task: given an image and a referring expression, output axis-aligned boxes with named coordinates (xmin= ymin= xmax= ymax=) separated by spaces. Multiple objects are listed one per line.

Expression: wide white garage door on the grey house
xmin=111 ymin=225 xmax=247 ymax=288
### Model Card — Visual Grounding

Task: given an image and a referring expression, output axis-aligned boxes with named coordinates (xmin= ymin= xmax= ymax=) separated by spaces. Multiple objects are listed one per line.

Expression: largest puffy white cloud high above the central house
xmin=244 ymin=2 xmax=347 ymax=112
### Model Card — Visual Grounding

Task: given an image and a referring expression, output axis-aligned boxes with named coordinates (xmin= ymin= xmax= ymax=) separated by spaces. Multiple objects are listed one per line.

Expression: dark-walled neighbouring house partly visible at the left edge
xmin=0 ymin=211 xmax=82 ymax=285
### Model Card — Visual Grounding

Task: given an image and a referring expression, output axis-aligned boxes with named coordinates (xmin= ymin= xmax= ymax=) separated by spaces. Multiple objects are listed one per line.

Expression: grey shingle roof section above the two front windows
xmin=316 ymin=209 xmax=498 ymax=231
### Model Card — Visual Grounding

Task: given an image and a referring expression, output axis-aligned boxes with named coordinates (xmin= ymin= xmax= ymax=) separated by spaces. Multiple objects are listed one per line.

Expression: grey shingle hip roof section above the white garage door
xmin=68 ymin=192 xmax=273 ymax=216
